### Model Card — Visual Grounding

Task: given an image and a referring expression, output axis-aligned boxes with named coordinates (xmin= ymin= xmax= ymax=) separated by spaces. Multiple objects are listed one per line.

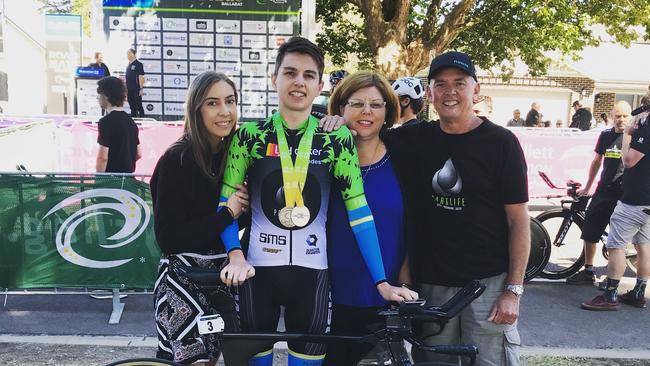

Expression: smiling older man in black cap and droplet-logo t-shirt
xmin=385 ymin=52 xmax=530 ymax=365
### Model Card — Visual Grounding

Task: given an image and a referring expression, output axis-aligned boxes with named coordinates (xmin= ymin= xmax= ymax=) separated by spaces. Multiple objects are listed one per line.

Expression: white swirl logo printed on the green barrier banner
xmin=43 ymin=188 xmax=151 ymax=268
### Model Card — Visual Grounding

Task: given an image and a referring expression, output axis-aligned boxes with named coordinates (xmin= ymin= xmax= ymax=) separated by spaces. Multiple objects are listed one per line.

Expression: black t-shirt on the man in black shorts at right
xmin=594 ymin=128 xmax=624 ymax=197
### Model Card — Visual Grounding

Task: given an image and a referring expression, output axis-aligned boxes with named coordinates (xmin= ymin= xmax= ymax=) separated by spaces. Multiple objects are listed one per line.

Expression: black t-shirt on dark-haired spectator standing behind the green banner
xmin=97 ymin=111 xmax=140 ymax=173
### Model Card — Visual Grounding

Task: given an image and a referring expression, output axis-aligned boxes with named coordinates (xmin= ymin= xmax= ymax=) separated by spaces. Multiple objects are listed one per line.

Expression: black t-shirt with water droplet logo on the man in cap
xmin=386 ymin=118 xmax=528 ymax=287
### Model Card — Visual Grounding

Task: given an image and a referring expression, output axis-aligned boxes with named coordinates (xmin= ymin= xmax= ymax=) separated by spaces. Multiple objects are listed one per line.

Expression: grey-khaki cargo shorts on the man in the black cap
xmin=411 ymin=273 xmax=521 ymax=366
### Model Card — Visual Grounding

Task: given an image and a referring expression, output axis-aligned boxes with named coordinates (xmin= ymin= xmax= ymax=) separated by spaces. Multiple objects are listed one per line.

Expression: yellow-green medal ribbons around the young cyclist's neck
xmin=271 ymin=113 xmax=318 ymax=207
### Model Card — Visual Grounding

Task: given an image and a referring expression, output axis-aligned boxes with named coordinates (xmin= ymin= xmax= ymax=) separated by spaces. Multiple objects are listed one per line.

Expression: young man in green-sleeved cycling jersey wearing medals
xmin=215 ymin=37 xmax=417 ymax=366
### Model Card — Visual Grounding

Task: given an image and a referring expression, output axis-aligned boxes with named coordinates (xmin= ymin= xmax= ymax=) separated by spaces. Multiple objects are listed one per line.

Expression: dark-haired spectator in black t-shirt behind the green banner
xmin=95 ymin=76 xmax=142 ymax=173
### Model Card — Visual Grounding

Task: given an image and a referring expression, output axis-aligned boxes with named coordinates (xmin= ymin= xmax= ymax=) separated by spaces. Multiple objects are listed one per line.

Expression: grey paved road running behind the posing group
xmin=0 ymin=277 xmax=650 ymax=365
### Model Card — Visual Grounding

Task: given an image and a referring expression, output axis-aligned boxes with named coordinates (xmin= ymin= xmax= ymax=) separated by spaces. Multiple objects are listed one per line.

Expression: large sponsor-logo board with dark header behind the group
xmin=103 ymin=0 xmax=301 ymax=121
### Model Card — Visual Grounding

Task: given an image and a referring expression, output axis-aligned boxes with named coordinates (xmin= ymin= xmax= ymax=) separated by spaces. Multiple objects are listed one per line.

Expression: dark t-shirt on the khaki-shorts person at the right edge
xmin=621 ymin=118 xmax=650 ymax=206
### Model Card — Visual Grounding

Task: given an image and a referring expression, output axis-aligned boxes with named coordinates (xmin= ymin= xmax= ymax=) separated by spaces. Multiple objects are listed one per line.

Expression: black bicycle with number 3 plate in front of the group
xmin=107 ymin=267 xmax=485 ymax=366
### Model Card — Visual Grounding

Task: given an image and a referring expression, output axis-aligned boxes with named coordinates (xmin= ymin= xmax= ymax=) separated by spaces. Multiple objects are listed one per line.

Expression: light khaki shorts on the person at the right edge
xmin=606 ymin=201 xmax=650 ymax=249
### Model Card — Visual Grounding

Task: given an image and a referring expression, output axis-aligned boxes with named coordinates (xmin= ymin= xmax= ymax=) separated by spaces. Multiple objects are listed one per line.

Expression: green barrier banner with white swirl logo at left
xmin=0 ymin=174 xmax=160 ymax=289
